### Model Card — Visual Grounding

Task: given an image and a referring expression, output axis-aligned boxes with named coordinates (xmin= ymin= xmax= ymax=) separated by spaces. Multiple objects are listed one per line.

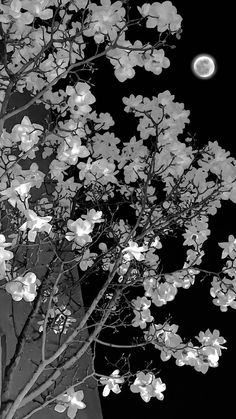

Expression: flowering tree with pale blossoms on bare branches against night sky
xmin=0 ymin=0 xmax=236 ymax=419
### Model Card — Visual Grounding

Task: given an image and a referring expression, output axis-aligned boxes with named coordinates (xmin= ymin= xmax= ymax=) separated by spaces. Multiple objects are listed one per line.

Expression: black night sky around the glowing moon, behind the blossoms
xmin=82 ymin=0 xmax=236 ymax=419
